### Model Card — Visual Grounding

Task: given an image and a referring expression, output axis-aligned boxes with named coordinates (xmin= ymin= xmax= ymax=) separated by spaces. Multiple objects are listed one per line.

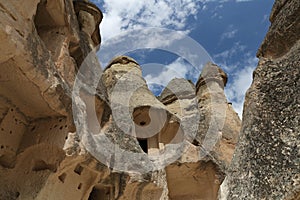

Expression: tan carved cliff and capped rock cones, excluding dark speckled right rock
xmin=0 ymin=0 xmax=244 ymax=200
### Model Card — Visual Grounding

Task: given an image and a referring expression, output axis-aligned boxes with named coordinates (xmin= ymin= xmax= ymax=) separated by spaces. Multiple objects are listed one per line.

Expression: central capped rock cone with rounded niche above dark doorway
xmin=102 ymin=56 xmax=178 ymax=153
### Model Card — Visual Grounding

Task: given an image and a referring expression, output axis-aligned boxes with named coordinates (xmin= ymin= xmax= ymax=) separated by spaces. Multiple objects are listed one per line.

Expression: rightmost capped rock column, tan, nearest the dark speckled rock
xmin=195 ymin=63 xmax=241 ymax=173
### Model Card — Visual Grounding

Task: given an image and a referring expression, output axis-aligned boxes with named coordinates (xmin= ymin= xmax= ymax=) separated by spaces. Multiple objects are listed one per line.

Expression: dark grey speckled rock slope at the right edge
xmin=222 ymin=0 xmax=300 ymax=200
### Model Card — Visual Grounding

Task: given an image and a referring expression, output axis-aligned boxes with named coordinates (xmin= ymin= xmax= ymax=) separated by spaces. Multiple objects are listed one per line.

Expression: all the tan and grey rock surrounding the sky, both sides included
xmin=0 ymin=0 xmax=299 ymax=200
